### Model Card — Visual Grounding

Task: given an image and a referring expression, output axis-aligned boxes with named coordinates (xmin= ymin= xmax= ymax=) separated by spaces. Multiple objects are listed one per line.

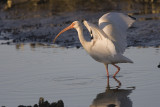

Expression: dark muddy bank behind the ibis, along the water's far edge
xmin=0 ymin=12 xmax=160 ymax=47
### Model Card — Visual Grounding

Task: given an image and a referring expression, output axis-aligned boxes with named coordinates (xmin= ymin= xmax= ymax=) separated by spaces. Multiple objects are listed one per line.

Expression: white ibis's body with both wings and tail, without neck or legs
xmin=83 ymin=12 xmax=134 ymax=64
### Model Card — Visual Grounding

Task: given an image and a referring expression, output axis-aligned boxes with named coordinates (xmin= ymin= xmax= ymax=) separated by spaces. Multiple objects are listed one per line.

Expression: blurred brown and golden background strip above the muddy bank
xmin=0 ymin=0 xmax=160 ymax=18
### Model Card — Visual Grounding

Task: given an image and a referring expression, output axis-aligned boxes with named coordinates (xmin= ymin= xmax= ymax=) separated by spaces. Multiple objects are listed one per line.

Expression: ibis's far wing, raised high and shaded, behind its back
xmin=99 ymin=12 xmax=135 ymax=54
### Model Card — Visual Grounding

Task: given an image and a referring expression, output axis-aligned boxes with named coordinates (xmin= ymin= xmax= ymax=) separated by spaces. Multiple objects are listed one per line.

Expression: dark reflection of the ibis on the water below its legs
xmin=90 ymin=78 xmax=135 ymax=107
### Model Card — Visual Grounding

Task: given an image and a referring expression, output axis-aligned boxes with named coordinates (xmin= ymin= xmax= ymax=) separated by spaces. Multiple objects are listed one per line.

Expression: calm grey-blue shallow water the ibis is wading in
xmin=0 ymin=45 xmax=160 ymax=107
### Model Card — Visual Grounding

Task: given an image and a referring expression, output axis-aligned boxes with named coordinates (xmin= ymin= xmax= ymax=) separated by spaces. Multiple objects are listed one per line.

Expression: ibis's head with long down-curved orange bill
xmin=53 ymin=21 xmax=80 ymax=43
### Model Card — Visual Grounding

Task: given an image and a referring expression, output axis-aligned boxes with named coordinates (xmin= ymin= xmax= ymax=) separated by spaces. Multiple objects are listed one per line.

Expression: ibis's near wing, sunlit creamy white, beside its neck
xmin=83 ymin=21 xmax=116 ymax=55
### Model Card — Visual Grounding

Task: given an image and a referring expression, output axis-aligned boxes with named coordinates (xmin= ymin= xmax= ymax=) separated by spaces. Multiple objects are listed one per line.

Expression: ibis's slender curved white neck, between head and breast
xmin=76 ymin=26 xmax=88 ymax=50
